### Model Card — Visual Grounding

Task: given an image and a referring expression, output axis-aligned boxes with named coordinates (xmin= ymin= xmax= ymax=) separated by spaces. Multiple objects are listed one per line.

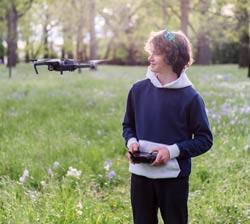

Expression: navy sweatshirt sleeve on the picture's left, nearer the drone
xmin=122 ymin=89 xmax=138 ymax=146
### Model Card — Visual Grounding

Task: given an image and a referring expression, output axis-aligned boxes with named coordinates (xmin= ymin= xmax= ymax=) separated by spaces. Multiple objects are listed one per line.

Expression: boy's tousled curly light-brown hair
xmin=144 ymin=30 xmax=193 ymax=77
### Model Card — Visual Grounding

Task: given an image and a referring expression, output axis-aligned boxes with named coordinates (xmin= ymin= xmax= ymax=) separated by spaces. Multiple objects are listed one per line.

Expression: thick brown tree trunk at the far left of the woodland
xmin=7 ymin=3 xmax=18 ymax=67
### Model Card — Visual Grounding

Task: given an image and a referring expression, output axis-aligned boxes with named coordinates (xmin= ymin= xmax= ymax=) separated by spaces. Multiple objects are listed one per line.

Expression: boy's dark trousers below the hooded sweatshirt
xmin=131 ymin=174 xmax=189 ymax=224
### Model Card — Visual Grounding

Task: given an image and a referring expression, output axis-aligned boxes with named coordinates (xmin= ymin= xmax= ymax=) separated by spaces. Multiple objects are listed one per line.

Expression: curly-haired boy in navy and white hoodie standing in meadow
xmin=123 ymin=30 xmax=213 ymax=224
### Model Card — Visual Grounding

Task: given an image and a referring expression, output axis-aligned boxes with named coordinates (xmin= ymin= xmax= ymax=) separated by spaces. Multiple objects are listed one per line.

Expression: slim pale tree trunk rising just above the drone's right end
xmin=89 ymin=0 xmax=97 ymax=60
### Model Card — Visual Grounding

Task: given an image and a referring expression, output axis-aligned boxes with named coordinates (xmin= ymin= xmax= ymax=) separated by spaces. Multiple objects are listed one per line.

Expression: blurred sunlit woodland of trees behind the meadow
xmin=0 ymin=0 xmax=250 ymax=72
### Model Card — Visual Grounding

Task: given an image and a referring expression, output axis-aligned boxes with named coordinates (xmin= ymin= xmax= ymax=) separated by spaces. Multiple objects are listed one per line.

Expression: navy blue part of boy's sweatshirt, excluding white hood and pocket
xmin=123 ymin=76 xmax=213 ymax=178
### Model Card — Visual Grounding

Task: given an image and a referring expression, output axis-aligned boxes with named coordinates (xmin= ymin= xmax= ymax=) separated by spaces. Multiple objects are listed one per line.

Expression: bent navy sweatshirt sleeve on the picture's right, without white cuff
xmin=177 ymin=94 xmax=213 ymax=158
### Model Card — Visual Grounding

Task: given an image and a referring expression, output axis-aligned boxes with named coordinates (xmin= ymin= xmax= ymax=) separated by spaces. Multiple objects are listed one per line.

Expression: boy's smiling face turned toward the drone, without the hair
xmin=148 ymin=48 xmax=167 ymax=73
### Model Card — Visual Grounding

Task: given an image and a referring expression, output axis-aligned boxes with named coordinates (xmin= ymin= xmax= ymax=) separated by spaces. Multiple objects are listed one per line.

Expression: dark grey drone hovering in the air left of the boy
xmin=33 ymin=59 xmax=105 ymax=75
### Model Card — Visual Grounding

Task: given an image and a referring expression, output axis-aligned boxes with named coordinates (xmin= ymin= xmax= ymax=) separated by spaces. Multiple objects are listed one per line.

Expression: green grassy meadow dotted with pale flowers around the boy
xmin=0 ymin=65 xmax=250 ymax=224
